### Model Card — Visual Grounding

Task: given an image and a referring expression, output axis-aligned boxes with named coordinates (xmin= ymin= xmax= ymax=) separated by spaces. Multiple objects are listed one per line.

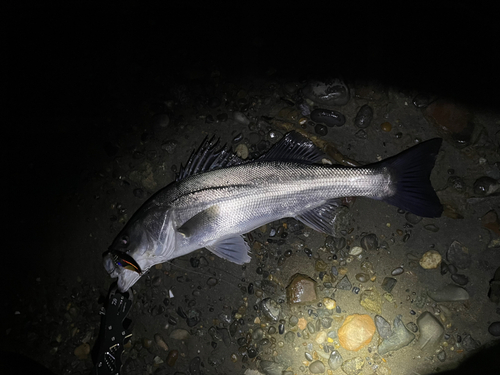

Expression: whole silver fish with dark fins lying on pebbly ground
xmin=103 ymin=131 xmax=443 ymax=292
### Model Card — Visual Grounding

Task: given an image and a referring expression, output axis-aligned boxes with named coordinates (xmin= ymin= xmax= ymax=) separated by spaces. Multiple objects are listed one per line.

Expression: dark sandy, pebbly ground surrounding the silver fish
xmin=0 ymin=7 xmax=500 ymax=375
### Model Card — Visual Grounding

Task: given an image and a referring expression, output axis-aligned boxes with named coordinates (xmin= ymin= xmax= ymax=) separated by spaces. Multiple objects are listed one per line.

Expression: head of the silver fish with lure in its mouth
xmin=103 ymin=209 xmax=175 ymax=293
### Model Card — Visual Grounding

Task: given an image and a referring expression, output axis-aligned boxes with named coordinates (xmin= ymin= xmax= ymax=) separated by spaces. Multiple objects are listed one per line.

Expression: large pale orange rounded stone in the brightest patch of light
xmin=337 ymin=314 xmax=376 ymax=351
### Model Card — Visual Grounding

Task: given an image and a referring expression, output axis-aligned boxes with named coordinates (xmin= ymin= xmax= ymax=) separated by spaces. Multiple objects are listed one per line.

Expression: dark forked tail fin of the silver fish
xmin=377 ymin=138 xmax=443 ymax=217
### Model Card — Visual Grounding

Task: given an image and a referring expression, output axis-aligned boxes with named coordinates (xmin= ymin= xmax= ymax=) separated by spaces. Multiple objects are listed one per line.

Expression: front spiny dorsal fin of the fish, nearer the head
xmin=176 ymin=136 xmax=243 ymax=181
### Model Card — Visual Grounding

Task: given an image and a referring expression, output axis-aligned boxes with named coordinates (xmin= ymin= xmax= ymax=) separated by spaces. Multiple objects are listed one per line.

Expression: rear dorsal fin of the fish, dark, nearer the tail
xmin=258 ymin=131 xmax=325 ymax=164
